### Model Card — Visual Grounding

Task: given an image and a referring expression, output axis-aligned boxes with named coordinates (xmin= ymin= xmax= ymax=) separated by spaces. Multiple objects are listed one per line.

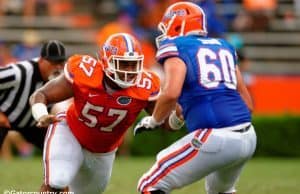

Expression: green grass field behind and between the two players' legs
xmin=0 ymin=157 xmax=300 ymax=194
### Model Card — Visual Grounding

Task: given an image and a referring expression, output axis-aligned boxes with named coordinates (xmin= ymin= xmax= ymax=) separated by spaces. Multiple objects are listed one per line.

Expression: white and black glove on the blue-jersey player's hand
xmin=133 ymin=116 xmax=164 ymax=136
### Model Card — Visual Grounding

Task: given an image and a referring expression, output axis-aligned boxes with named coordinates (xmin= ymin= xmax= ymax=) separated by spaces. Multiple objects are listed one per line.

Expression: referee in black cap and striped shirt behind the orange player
xmin=0 ymin=40 xmax=66 ymax=149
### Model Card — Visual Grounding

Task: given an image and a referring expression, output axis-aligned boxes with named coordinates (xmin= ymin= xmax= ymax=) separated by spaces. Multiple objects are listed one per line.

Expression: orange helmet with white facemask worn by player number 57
xmin=101 ymin=33 xmax=144 ymax=88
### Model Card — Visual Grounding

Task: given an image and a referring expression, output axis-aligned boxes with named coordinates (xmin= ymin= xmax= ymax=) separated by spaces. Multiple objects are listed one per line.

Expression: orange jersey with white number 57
xmin=65 ymin=55 xmax=160 ymax=152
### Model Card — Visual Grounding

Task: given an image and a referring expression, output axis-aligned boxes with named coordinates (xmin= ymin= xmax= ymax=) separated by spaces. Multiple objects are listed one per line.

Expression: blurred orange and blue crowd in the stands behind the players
xmin=0 ymin=0 xmax=288 ymax=66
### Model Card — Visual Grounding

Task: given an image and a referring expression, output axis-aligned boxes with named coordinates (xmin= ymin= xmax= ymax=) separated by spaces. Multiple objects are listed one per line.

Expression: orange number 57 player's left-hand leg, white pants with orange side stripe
xmin=43 ymin=121 xmax=84 ymax=191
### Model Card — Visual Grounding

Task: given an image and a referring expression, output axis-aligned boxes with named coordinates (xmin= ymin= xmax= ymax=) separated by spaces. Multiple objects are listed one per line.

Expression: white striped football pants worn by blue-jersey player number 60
xmin=138 ymin=123 xmax=256 ymax=194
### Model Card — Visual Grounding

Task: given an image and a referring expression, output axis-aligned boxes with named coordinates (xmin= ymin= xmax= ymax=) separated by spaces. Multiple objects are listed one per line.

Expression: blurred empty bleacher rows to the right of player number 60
xmin=241 ymin=0 xmax=300 ymax=74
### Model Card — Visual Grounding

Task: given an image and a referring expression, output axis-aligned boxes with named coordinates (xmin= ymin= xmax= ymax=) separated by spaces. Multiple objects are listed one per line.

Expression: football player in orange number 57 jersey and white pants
xmin=30 ymin=33 xmax=183 ymax=194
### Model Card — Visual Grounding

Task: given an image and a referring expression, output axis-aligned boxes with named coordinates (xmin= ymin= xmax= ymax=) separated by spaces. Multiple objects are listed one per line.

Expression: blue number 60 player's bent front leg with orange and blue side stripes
xmin=138 ymin=129 xmax=254 ymax=193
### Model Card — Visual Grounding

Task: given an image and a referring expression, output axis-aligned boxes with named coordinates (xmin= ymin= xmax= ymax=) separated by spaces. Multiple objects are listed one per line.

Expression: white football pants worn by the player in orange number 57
xmin=43 ymin=120 xmax=116 ymax=194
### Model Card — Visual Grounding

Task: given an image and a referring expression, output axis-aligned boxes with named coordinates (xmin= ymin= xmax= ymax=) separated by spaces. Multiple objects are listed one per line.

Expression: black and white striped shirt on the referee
xmin=0 ymin=58 xmax=45 ymax=129
